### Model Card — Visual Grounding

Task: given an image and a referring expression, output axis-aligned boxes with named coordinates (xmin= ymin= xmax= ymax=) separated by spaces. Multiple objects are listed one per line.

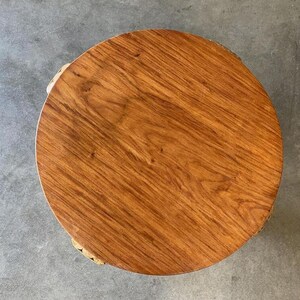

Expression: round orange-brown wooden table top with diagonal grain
xmin=36 ymin=30 xmax=282 ymax=274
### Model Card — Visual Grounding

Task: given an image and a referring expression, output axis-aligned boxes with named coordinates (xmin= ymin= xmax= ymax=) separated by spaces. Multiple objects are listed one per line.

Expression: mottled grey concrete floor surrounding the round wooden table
xmin=0 ymin=0 xmax=300 ymax=300
